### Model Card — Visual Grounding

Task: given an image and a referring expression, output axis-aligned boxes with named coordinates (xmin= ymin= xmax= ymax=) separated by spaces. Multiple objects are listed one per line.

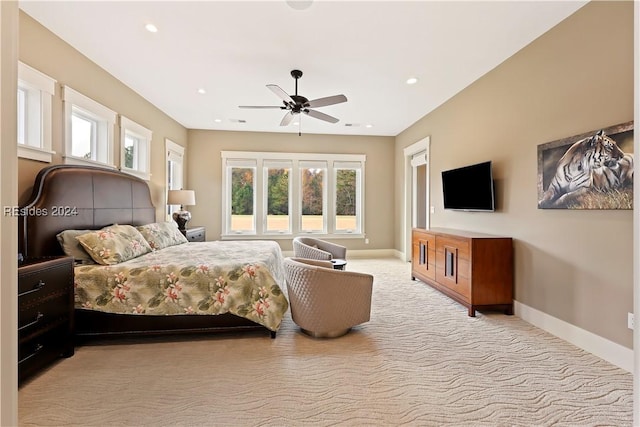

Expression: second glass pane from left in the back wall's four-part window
xmin=267 ymin=168 xmax=291 ymax=232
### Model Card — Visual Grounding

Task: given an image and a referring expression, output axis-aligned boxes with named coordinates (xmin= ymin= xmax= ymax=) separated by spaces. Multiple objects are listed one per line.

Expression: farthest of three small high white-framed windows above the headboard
xmin=120 ymin=116 xmax=153 ymax=181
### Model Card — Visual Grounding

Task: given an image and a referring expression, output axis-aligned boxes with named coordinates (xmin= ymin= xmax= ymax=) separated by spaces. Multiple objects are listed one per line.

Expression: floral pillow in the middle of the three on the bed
xmin=76 ymin=224 xmax=151 ymax=265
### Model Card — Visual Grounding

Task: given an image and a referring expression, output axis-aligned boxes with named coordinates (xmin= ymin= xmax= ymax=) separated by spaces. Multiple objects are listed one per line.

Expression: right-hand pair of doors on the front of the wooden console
xmin=436 ymin=236 xmax=471 ymax=301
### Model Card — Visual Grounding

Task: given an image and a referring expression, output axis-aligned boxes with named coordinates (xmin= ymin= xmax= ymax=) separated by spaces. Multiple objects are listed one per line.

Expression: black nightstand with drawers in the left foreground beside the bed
xmin=18 ymin=257 xmax=74 ymax=382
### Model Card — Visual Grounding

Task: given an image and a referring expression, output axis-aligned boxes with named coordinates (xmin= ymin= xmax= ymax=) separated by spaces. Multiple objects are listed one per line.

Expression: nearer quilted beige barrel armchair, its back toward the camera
xmin=284 ymin=258 xmax=373 ymax=338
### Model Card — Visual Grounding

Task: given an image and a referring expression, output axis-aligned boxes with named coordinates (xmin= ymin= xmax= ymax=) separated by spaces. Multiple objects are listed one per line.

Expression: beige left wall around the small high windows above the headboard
xmin=18 ymin=11 xmax=187 ymax=219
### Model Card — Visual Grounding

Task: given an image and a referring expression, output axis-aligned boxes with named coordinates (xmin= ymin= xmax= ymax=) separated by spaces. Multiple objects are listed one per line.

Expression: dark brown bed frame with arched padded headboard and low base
xmin=19 ymin=165 xmax=276 ymax=338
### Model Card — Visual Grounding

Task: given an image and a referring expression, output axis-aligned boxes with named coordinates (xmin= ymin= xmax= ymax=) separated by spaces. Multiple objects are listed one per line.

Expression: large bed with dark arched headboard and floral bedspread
xmin=19 ymin=165 xmax=288 ymax=339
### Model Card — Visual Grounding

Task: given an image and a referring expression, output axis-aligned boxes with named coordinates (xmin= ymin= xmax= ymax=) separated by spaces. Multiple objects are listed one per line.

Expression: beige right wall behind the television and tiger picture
xmin=394 ymin=2 xmax=634 ymax=348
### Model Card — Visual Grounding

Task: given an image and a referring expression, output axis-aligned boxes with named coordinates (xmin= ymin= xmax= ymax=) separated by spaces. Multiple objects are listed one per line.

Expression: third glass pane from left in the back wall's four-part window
xmin=300 ymin=168 xmax=325 ymax=231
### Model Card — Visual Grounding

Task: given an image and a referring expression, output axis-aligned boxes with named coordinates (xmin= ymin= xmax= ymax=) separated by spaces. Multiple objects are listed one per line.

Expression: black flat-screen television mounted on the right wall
xmin=442 ymin=161 xmax=495 ymax=211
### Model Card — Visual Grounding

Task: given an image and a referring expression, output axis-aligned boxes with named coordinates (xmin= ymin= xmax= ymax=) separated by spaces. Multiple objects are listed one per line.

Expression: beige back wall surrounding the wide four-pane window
xmin=187 ymin=130 xmax=394 ymax=250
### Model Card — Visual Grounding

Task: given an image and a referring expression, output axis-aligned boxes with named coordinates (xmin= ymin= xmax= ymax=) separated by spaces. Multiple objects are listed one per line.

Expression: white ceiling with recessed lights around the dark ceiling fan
xmin=20 ymin=0 xmax=586 ymax=136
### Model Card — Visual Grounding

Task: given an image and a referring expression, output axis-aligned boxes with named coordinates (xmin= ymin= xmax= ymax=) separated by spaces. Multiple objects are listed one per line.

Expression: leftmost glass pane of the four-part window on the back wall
xmin=231 ymin=168 xmax=255 ymax=231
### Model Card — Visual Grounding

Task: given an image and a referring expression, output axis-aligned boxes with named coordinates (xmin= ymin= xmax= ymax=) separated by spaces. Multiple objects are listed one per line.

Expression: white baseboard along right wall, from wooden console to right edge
xmin=513 ymin=301 xmax=633 ymax=373
